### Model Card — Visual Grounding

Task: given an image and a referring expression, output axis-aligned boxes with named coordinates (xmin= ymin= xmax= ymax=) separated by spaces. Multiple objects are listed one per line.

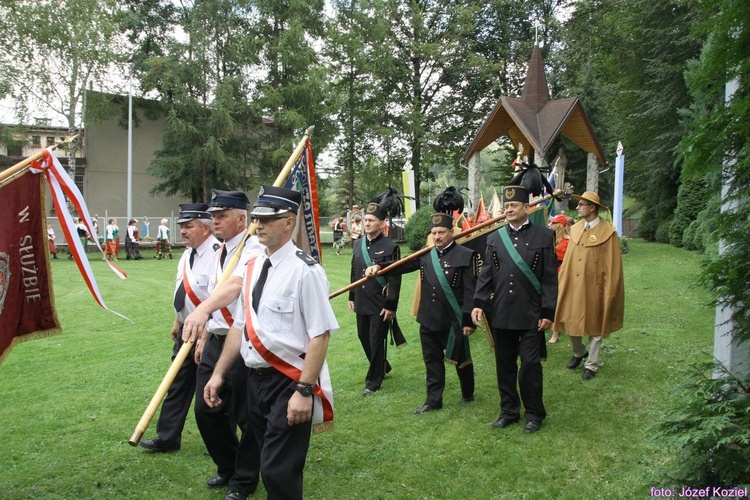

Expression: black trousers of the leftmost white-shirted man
xmin=156 ymin=334 xmax=196 ymax=448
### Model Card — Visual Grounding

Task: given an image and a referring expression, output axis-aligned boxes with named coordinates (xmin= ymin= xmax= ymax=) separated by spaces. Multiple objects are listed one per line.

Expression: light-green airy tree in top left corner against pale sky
xmin=0 ymin=0 xmax=121 ymax=174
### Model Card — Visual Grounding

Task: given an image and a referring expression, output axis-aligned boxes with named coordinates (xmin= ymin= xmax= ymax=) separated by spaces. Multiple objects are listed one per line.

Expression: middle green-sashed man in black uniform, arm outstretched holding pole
xmin=367 ymin=213 xmax=479 ymax=414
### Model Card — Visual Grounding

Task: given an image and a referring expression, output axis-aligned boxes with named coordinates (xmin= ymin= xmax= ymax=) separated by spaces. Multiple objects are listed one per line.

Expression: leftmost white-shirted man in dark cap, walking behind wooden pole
xmin=140 ymin=203 xmax=221 ymax=452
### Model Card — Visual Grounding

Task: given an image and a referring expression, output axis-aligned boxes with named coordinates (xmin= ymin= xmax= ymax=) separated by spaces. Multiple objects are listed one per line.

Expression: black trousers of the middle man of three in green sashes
xmin=419 ymin=327 xmax=474 ymax=408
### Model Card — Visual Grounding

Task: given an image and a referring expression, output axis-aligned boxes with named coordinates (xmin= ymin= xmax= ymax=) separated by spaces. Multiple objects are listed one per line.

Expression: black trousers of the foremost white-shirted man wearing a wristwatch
xmin=247 ymin=368 xmax=312 ymax=499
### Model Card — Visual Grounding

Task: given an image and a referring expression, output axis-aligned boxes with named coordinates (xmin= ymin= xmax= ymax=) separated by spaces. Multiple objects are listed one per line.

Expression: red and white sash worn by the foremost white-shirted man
xmin=245 ymin=258 xmax=333 ymax=432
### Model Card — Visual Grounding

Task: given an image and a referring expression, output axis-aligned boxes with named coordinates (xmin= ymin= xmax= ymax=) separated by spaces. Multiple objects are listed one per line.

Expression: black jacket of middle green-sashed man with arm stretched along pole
xmin=386 ymin=242 xmax=479 ymax=331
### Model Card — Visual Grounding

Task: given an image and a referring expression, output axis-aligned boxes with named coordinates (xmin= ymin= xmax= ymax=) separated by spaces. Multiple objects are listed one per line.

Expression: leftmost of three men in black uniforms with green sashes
xmin=349 ymin=202 xmax=401 ymax=396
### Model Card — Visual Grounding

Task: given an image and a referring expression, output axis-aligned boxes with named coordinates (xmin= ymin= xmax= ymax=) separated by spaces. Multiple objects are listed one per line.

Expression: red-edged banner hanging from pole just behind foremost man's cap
xmin=284 ymin=141 xmax=323 ymax=263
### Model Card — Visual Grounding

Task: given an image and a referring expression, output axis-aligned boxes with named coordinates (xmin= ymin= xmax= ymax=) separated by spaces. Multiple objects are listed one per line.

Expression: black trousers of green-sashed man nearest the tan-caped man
xmin=492 ymin=328 xmax=547 ymax=422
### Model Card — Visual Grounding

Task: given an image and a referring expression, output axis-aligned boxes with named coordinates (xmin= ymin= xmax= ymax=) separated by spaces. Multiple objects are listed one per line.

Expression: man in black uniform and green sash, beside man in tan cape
xmin=471 ymin=186 xmax=557 ymax=433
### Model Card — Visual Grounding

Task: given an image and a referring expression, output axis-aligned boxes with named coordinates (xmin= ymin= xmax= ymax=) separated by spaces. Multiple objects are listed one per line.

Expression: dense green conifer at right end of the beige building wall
xmin=127 ymin=0 xmax=270 ymax=201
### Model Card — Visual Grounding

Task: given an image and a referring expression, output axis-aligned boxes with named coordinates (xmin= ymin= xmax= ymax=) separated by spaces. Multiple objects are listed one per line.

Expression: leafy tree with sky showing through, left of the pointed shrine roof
xmin=366 ymin=0 xmax=500 ymax=207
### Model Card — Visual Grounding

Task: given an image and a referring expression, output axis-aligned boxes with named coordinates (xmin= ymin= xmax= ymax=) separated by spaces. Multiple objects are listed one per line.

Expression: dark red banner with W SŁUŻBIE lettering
xmin=0 ymin=173 xmax=60 ymax=362
